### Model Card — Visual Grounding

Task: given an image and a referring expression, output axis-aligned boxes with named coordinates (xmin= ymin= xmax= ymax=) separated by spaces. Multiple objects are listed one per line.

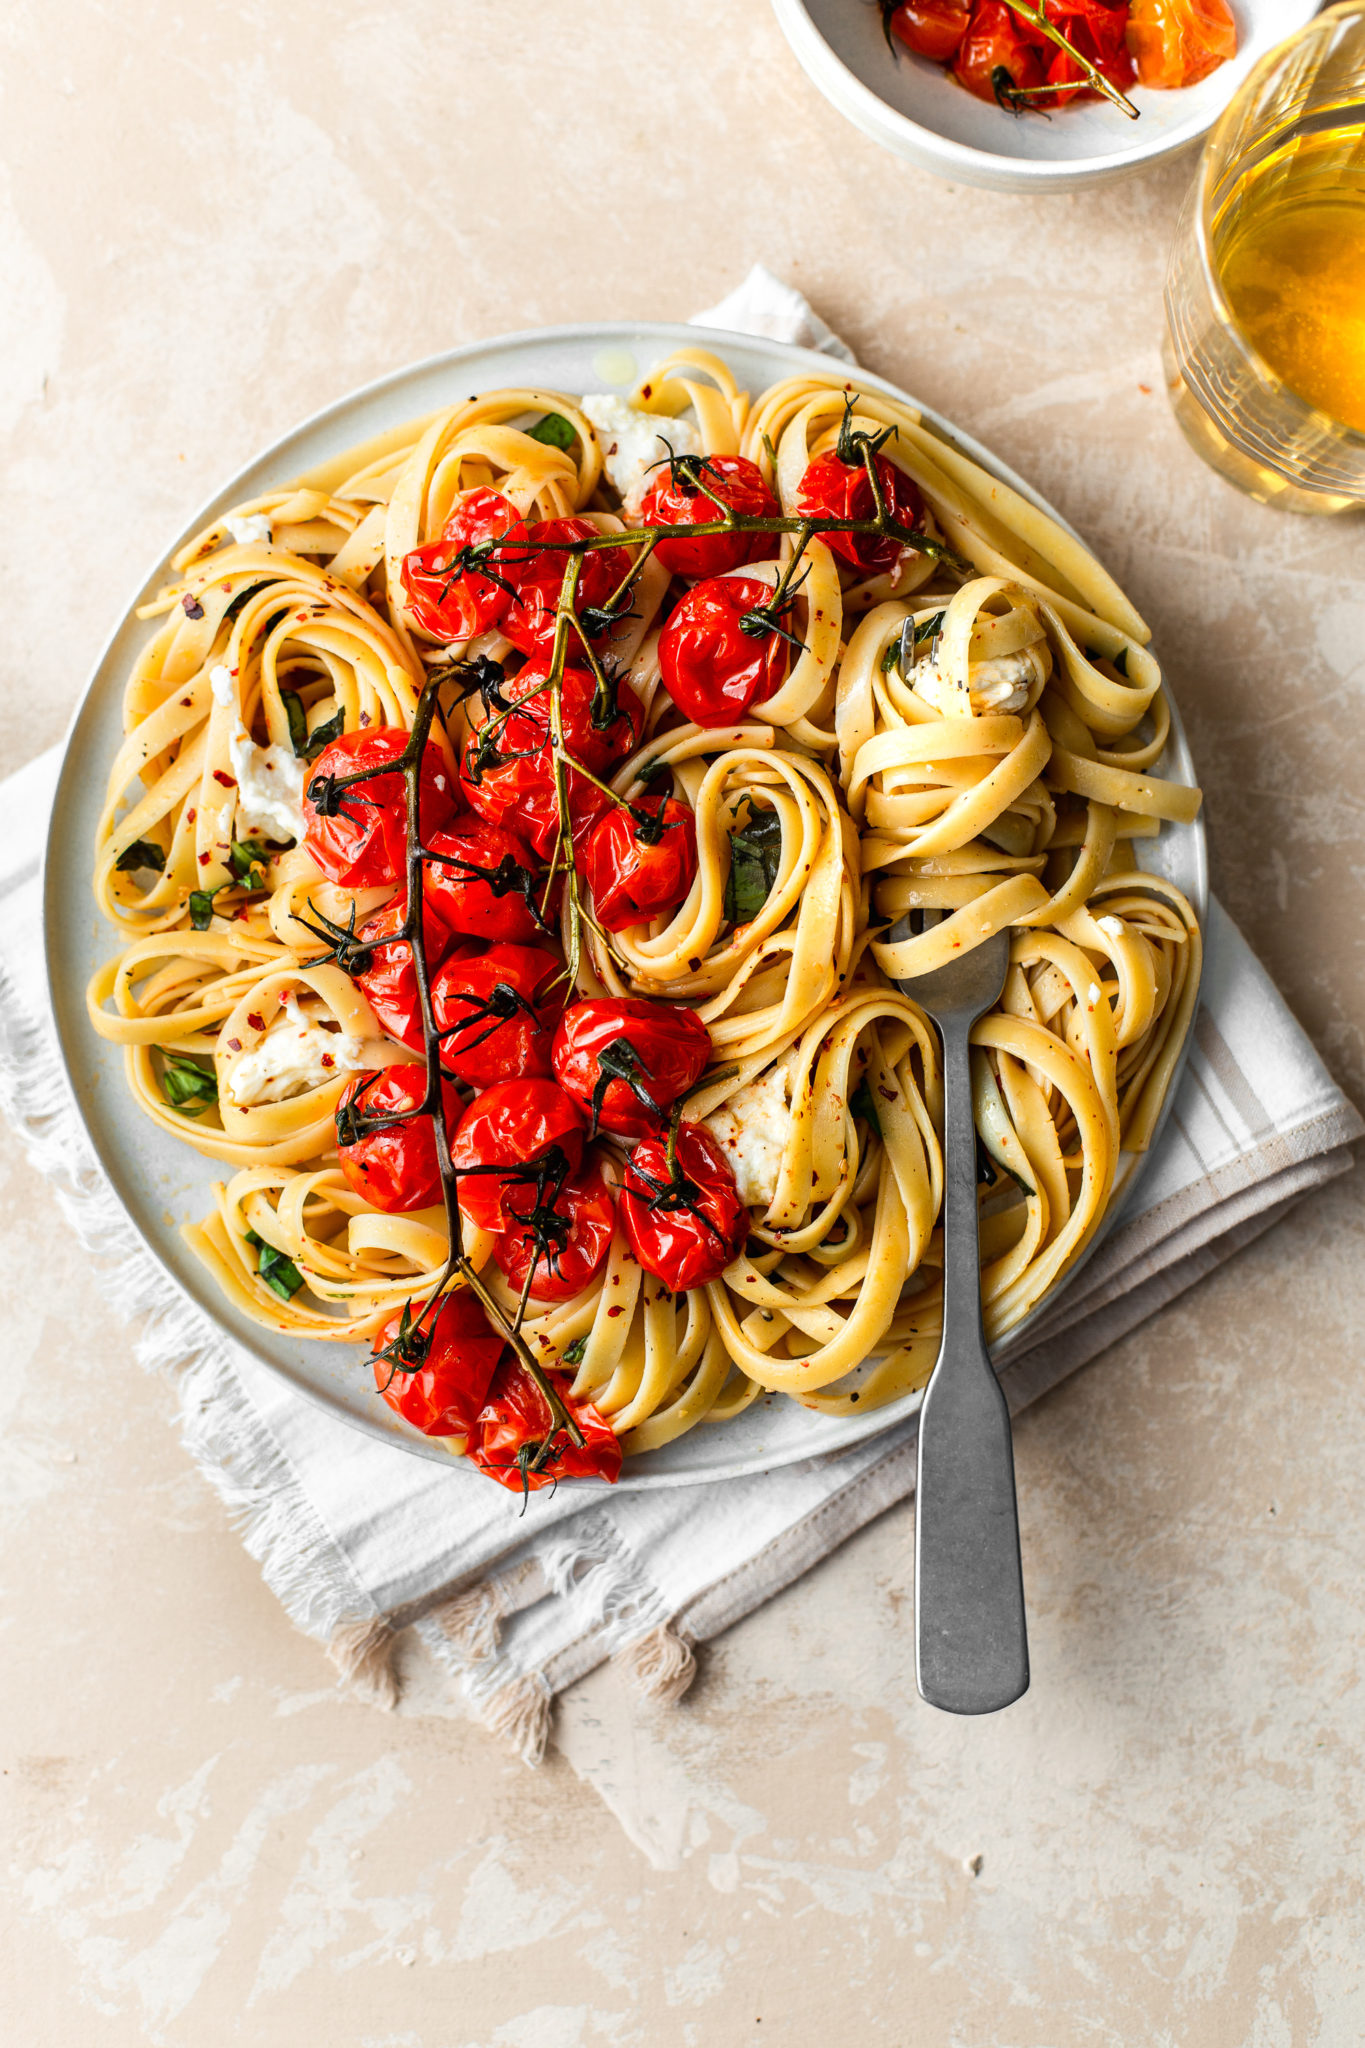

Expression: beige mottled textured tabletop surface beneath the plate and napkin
xmin=0 ymin=0 xmax=1365 ymax=2048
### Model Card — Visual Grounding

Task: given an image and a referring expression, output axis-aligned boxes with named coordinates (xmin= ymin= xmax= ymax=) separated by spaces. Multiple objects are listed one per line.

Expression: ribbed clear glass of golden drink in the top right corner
xmin=1164 ymin=0 xmax=1365 ymax=512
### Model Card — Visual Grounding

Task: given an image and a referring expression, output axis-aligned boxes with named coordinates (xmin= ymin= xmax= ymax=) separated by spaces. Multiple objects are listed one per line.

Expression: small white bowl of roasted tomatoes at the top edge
xmin=774 ymin=0 xmax=1318 ymax=193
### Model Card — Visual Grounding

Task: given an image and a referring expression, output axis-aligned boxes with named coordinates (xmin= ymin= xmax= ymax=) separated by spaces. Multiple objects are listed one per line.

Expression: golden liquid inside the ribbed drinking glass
xmin=1214 ymin=127 xmax=1365 ymax=432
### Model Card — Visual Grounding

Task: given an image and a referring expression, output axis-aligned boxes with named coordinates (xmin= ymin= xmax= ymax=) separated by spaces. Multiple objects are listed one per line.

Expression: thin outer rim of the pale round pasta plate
xmin=39 ymin=322 xmax=1207 ymax=1495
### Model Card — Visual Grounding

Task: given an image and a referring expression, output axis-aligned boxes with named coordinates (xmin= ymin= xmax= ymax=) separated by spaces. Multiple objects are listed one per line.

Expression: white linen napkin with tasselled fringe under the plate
xmin=0 ymin=276 xmax=1365 ymax=1761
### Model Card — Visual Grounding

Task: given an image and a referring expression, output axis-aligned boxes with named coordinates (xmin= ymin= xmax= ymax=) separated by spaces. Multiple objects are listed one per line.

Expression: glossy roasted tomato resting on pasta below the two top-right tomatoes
xmin=659 ymin=575 xmax=788 ymax=725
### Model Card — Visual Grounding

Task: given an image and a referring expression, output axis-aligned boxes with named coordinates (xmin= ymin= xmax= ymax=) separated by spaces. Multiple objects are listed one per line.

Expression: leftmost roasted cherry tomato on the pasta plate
xmin=303 ymin=725 xmax=456 ymax=889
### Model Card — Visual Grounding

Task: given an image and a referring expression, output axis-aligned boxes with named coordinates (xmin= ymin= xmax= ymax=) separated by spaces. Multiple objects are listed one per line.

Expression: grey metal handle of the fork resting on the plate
xmin=915 ymin=1018 xmax=1029 ymax=1714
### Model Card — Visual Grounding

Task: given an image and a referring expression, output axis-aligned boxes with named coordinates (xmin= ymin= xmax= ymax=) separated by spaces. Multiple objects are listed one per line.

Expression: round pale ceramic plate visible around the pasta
xmin=43 ymin=326 xmax=1207 ymax=1487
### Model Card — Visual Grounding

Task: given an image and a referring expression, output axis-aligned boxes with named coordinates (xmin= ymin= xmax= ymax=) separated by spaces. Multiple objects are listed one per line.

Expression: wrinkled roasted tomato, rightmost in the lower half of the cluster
xmin=620 ymin=1124 xmax=749 ymax=1294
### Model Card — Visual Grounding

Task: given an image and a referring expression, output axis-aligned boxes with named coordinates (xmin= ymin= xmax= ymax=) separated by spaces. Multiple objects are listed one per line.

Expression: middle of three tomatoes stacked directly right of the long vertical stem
xmin=432 ymin=940 xmax=565 ymax=1087
